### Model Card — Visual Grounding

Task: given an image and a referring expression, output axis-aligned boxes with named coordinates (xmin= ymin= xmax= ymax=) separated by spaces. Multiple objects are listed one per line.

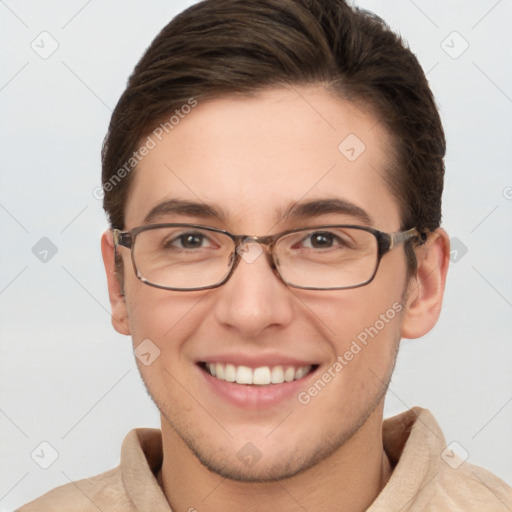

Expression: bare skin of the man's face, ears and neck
xmin=102 ymin=87 xmax=449 ymax=512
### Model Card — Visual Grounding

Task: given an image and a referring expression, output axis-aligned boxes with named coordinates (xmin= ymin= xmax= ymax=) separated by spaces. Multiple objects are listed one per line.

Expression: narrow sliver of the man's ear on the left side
xmin=101 ymin=230 xmax=130 ymax=335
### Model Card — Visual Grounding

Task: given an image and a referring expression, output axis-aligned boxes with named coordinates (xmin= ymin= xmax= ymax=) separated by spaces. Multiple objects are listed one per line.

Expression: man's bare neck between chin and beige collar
xmin=159 ymin=406 xmax=391 ymax=512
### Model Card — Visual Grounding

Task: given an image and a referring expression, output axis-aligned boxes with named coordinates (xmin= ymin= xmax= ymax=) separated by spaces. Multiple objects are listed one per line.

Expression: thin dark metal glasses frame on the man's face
xmin=112 ymin=223 xmax=427 ymax=292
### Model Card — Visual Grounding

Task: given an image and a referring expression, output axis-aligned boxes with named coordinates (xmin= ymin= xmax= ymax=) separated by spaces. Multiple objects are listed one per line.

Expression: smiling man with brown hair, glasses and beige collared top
xmin=20 ymin=0 xmax=512 ymax=512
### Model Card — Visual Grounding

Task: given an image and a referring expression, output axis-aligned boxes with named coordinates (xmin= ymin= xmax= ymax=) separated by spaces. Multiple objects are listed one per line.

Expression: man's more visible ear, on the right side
xmin=402 ymin=228 xmax=450 ymax=338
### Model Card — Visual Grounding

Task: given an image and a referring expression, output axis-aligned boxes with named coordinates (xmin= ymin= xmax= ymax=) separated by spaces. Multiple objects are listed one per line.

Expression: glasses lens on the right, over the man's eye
xmin=275 ymin=227 xmax=378 ymax=290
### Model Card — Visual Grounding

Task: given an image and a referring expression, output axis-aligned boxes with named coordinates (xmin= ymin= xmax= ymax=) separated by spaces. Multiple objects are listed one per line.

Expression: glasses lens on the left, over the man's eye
xmin=133 ymin=226 xmax=234 ymax=290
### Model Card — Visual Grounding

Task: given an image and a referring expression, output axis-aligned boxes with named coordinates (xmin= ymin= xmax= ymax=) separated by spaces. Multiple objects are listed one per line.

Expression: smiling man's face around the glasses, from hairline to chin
xmin=108 ymin=88 xmax=407 ymax=481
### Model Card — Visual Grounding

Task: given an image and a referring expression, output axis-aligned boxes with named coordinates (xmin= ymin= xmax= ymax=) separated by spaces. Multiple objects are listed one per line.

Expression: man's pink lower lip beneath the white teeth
xmin=198 ymin=366 xmax=316 ymax=409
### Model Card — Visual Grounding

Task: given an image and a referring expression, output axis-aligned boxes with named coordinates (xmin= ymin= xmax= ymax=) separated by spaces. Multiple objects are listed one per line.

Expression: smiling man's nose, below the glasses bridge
xmin=211 ymin=243 xmax=294 ymax=338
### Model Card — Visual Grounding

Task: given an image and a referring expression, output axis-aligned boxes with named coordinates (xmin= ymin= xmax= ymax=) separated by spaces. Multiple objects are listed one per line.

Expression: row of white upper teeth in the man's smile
xmin=206 ymin=363 xmax=311 ymax=386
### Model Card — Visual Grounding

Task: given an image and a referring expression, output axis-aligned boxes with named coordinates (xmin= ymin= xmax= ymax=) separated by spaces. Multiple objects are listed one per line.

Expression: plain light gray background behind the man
xmin=0 ymin=0 xmax=512 ymax=510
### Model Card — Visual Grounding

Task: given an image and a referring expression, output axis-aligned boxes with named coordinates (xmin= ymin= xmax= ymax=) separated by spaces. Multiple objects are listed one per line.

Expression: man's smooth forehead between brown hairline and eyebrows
xmin=125 ymin=87 xmax=399 ymax=233
